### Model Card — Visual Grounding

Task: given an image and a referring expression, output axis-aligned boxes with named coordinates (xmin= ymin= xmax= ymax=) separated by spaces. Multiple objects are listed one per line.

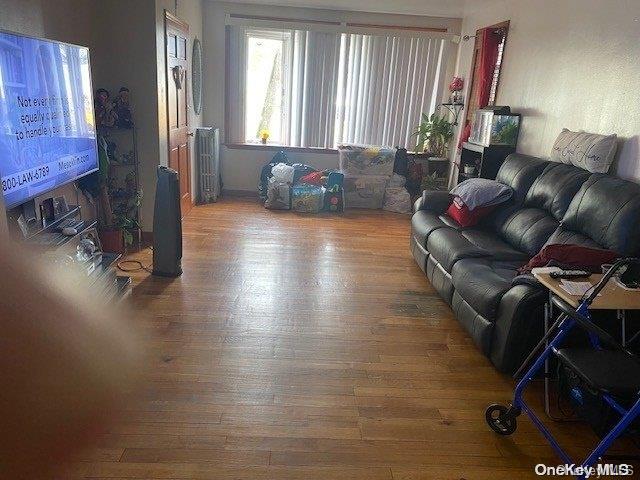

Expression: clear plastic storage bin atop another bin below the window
xmin=338 ymin=145 xmax=396 ymax=177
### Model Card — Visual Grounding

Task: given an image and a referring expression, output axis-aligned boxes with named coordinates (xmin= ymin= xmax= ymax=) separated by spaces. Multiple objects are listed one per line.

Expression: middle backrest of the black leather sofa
xmin=496 ymin=162 xmax=590 ymax=256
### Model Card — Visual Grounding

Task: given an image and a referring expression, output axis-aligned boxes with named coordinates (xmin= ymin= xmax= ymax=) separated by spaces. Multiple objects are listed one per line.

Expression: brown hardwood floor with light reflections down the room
xmin=69 ymin=199 xmax=636 ymax=480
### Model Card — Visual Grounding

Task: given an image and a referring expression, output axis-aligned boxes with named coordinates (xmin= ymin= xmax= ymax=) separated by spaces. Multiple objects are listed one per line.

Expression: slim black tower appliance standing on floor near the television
xmin=153 ymin=166 xmax=182 ymax=277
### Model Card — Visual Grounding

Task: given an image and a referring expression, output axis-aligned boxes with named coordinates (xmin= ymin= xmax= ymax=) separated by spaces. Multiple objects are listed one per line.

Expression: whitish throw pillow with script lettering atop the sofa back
xmin=551 ymin=128 xmax=618 ymax=173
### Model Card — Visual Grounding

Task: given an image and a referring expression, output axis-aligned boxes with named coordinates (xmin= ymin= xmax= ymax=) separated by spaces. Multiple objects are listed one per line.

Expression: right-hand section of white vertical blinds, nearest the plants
xmin=335 ymin=34 xmax=446 ymax=148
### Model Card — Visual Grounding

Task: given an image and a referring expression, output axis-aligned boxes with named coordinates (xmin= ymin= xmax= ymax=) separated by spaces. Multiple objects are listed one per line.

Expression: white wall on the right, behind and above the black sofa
xmin=459 ymin=0 xmax=640 ymax=180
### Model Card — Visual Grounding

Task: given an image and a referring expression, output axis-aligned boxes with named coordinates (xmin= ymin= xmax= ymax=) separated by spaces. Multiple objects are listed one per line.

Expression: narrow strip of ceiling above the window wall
xmin=222 ymin=0 xmax=465 ymax=18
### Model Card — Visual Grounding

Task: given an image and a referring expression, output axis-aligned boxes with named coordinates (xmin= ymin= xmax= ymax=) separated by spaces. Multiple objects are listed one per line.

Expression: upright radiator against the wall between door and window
xmin=196 ymin=127 xmax=222 ymax=203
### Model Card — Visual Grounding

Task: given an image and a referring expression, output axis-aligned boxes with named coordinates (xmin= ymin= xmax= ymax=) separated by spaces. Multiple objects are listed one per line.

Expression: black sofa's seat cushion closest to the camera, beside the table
xmin=451 ymin=258 xmax=521 ymax=321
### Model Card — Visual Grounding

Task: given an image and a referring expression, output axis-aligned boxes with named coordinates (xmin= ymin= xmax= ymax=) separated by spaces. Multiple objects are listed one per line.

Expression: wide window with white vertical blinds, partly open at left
xmin=226 ymin=25 xmax=447 ymax=148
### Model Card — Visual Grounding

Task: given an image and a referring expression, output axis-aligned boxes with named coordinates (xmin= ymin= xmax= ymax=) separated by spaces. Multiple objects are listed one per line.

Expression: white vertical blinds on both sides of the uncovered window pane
xmin=227 ymin=25 xmax=448 ymax=149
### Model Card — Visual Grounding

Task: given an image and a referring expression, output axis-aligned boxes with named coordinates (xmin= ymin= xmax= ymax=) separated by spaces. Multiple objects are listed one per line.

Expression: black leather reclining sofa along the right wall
xmin=411 ymin=154 xmax=640 ymax=373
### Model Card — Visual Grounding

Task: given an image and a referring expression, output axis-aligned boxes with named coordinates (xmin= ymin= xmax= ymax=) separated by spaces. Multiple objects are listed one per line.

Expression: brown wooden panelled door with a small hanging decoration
xmin=165 ymin=12 xmax=193 ymax=216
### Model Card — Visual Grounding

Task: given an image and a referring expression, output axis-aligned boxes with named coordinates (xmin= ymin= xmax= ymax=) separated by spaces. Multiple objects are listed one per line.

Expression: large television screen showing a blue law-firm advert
xmin=0 ymin=32 xmax=98 ymax=208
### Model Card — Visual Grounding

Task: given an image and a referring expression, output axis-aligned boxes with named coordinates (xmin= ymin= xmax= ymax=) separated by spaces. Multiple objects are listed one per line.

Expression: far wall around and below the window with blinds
xmin=203 ymin=0 xmax=461 ymax=191
